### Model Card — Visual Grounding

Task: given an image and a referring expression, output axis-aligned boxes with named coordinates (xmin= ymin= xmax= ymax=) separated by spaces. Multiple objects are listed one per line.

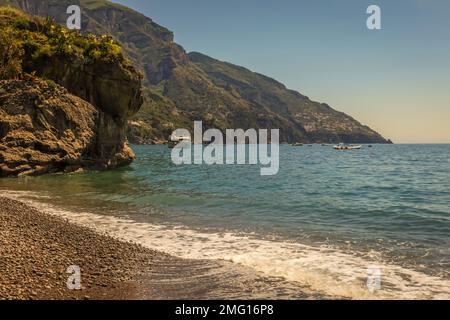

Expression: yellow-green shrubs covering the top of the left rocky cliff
xmin=0 ymin=7 xmax=131 ymax=79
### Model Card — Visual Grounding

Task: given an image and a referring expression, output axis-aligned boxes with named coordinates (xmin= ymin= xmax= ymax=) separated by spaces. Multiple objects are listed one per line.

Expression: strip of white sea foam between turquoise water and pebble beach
xmin=2 ymin=192 xmax=450 ymax=299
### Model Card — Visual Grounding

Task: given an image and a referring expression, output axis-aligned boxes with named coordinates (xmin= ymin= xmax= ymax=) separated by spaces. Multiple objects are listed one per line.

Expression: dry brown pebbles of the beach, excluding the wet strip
xmin=0 ymin=197 xmax=165 ymax=300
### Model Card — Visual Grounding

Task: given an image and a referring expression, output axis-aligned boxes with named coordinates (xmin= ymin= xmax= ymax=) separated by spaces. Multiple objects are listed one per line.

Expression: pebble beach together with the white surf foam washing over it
xmin=0 ymin=182 xmax=448 ymax=300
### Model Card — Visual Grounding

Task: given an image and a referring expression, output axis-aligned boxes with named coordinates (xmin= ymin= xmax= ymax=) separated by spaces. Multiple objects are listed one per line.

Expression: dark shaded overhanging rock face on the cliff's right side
xmin=27 ymin=57 xmax=143 ymax=167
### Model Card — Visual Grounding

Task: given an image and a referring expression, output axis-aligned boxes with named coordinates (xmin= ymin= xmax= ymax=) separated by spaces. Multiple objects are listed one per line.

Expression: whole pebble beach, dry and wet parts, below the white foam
xmin=0 ymin=196 xmax=320 ymax=300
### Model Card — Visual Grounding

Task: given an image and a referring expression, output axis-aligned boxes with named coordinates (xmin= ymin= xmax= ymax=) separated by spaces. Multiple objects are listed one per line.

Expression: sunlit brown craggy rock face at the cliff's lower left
xmin=0 ymin=79 xmax=133 ymax=177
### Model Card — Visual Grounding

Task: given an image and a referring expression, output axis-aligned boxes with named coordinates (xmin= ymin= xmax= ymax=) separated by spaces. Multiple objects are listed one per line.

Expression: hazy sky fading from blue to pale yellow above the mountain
xmin=115 ymin=0 xmax=450 ymax=143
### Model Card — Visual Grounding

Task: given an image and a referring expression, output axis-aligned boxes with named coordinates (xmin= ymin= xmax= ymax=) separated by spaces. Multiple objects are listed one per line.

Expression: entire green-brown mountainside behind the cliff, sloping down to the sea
xmin=0 ymin=0 xmax=387 ymax=143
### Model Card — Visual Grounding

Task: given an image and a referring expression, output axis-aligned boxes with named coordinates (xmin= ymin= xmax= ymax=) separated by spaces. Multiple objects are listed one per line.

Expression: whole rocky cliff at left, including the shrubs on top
xmin=0 ymin=8 xmax=143 ymax=176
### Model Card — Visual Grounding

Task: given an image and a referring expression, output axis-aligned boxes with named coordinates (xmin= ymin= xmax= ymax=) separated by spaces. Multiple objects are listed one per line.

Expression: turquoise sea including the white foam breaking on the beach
xmin=0 ymin=145 xmax=450 ymax=298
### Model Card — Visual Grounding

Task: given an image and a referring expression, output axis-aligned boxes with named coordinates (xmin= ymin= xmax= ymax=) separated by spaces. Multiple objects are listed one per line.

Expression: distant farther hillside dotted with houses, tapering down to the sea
xmin=189 ymin=52 xmax=384 ymax=142
